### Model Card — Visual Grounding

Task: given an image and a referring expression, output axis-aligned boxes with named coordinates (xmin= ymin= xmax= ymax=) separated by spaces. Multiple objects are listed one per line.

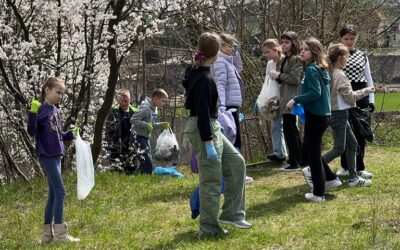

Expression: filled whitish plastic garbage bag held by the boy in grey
xmin=154 ymin=128 xmax=179 ymax=162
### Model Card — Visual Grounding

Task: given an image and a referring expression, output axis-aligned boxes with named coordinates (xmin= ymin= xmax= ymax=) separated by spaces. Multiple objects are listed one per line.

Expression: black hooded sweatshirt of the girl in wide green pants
xmin=182 ymin=66 xmax=218 ymax=141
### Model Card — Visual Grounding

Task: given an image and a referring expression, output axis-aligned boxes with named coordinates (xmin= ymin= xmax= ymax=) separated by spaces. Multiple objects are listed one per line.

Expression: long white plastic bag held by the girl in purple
xmin=74 ymin=136 xmax=94 ymax=200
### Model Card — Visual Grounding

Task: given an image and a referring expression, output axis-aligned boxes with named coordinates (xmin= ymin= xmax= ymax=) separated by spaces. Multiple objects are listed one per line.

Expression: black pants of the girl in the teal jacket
xmin=304 ymin=111 xmax=330 ymax=196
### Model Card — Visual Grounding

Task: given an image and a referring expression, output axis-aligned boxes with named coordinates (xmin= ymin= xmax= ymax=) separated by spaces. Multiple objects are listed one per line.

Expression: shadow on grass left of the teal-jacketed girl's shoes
xmin=246 ymin=185 xmax=336 ymax=220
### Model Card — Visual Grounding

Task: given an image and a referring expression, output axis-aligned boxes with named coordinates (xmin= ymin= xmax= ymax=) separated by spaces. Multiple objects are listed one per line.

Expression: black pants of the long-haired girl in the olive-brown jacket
xmin=282 ymin=114 xmax=302 ymax=166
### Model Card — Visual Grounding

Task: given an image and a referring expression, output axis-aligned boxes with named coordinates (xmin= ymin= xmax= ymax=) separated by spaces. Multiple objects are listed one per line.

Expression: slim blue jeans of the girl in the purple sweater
xmin=39 ymin=156 xmax=65 ymax=224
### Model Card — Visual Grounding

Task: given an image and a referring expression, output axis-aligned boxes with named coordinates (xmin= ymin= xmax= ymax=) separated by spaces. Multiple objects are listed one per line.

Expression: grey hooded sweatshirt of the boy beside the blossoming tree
xmin=131 ymin=97 xmax=161 ymax=138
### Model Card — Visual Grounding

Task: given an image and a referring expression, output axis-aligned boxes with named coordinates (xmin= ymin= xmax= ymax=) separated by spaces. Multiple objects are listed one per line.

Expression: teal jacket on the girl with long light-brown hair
xmin=294 ymin=62 xmax=331 ymax=116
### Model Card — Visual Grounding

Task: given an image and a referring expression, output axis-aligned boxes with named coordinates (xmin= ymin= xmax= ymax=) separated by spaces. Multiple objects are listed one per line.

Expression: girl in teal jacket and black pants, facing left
xmin=286 ymin=38 xmax=331 ymax=202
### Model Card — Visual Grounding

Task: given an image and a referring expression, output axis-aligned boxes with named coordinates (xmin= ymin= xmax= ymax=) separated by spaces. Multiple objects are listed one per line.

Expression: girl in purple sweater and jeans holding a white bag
xmin=28 ymin=77 xmax=79 ymax=243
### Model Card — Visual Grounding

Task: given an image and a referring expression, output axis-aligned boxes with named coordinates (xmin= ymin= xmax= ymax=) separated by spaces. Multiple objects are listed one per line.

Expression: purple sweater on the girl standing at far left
xmin=28 ymin=102 xmax=74 ymax=156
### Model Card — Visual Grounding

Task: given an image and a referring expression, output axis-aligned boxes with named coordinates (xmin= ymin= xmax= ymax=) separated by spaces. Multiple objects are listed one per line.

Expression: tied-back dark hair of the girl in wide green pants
xmin=195 ymin=32 xmax=221 ymax=67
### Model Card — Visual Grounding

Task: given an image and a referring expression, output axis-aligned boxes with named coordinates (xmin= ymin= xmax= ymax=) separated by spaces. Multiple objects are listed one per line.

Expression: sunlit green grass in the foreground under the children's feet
xmin=0 ymin=145 xmax=400 ymax=249
